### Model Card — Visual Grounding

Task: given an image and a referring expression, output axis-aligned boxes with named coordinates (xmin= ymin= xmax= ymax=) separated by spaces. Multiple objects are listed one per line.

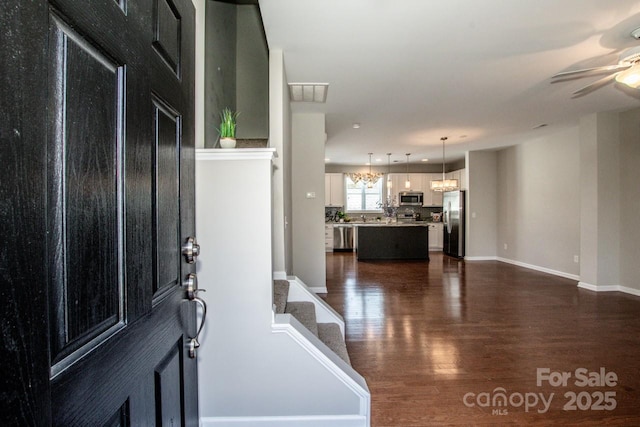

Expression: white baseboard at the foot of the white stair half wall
xmin=200 ymin=415 xmax=366 ymax=427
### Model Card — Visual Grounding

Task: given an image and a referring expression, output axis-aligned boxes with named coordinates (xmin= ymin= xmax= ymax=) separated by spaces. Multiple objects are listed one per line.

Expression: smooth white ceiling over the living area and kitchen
xmin=259 ymin=0 xmax=640 ymax=165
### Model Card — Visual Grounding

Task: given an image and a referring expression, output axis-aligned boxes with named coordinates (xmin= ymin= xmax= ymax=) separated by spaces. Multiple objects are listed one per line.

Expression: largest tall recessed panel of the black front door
xmin=48 ymin=11 xmax=124 ymax=374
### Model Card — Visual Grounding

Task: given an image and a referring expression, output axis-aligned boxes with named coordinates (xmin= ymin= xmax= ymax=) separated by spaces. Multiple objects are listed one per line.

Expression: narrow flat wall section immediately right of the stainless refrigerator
xmin=465 ymin=151 xmax=498 ymax=259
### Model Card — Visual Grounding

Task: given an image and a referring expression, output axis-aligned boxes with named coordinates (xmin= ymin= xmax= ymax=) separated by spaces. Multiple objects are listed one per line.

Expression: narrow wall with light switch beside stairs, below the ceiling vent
xmin=291 ymin=113 xmax=326 ymax=288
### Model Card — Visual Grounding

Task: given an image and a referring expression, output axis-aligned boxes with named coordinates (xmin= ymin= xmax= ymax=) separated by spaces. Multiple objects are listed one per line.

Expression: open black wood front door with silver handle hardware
xmin=0 ymin=0 xmax=197 ymax=426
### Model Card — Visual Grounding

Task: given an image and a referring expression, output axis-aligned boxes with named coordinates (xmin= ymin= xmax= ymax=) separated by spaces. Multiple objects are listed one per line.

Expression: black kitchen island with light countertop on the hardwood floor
xmin=354 ymin=223 xmax=429 ymax=260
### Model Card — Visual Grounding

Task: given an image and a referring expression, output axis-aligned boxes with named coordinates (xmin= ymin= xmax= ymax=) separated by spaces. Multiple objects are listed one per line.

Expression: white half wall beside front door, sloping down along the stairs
xmin=196 ymin=148 xmax=369 ymax=426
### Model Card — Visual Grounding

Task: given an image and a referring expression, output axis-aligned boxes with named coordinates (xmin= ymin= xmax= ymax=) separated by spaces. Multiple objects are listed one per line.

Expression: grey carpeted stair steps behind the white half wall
xmin=273 ymin=280 xmax=351 ymax=365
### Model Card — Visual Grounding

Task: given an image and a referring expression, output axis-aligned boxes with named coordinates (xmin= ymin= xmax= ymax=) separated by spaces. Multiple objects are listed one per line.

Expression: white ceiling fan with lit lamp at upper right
xmin=551 ymin=28 xmax=640 ymax=98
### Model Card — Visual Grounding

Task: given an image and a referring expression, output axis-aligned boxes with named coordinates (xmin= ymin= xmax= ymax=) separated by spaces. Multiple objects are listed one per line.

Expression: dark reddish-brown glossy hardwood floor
xmin=326 ymin=253 xmax=640 ymax=427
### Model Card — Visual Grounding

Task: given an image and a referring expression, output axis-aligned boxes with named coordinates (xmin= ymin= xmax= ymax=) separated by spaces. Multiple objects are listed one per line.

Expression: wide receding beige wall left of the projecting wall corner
xmin=498 ymin=127 xmax=581 ymax=276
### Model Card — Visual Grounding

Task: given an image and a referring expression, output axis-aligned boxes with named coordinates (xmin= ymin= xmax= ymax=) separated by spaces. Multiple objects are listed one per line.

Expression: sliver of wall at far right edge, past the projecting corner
xmin=620 ymin=108 xmax=640 ymax=292
